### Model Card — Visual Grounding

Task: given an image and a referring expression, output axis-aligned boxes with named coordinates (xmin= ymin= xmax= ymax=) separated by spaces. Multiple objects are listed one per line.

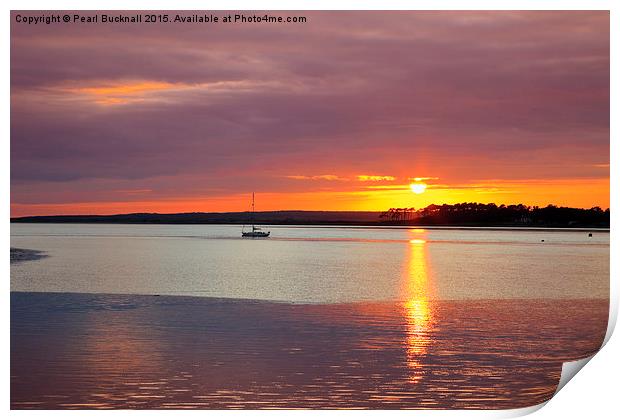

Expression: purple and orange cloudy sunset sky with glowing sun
xmin=11 ymin=11 xmax=610 ymax=217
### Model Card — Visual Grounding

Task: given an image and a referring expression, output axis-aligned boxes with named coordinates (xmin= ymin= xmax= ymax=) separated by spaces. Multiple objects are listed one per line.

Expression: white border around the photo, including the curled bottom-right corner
xmin=0 ymin=0 xmax=620 ymax=419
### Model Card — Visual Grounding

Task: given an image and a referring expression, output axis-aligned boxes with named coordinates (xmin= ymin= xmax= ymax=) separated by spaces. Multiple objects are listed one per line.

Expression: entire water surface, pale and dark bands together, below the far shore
xmin=11 ymin=225 xmax=609 ymax=408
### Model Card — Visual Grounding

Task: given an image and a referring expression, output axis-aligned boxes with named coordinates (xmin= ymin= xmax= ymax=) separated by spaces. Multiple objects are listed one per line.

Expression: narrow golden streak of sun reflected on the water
xmin=404 ymin=229 xmax=433 ymax=383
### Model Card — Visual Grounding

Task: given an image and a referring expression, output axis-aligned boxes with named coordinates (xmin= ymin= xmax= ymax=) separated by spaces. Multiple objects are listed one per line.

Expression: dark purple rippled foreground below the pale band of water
xmin=11 ymin=292 xmax=608 ymax=409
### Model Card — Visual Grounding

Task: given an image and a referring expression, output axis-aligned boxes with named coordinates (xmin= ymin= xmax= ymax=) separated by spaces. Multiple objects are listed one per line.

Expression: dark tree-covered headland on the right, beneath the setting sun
xmin=379 ymin=203 xmax=609 ymax=227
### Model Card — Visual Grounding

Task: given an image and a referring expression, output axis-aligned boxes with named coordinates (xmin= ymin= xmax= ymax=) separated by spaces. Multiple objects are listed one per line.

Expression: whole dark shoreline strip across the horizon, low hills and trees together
xmin=11 ymin=203 xmax=609 ymax=228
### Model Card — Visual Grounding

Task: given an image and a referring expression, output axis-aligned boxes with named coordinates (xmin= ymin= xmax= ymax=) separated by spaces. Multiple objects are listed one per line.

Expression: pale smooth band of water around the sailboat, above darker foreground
xmin=11 ymin=224 xmax=609 ymax=303
